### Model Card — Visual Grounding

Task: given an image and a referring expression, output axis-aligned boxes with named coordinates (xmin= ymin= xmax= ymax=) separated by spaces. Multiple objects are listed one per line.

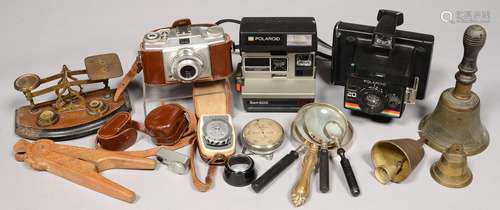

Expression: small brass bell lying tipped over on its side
xmin=372 ymin=139 xmax=424 ymax=184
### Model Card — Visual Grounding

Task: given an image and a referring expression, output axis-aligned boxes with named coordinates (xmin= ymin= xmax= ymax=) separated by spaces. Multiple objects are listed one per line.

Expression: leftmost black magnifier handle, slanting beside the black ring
xmin=252 ymin=150 xmax=299 ymax=193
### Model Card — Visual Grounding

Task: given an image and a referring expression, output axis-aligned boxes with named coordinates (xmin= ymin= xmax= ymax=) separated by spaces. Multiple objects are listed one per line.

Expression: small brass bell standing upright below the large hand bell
xmin=431 ymin=144 xmax=472 ymax=188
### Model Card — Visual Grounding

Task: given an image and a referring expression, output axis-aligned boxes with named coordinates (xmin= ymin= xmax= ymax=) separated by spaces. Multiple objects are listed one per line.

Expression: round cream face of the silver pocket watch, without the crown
xmin=243 ymin=118 xmax=283 ymax=149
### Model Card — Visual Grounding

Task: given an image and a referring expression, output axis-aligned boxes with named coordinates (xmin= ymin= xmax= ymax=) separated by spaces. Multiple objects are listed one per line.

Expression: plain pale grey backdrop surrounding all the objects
xmin=0 ymin=0 xmax=500 ymax=210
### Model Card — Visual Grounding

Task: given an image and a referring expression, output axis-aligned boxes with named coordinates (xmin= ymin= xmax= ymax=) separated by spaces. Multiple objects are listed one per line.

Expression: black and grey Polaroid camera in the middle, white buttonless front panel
xmin=236 ymin=17 xmax=317 ymax=112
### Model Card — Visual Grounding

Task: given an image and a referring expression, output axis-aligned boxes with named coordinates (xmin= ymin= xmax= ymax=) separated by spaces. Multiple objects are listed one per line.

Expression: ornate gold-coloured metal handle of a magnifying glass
xmin=290 ymin=144 xmax=318 ymax=207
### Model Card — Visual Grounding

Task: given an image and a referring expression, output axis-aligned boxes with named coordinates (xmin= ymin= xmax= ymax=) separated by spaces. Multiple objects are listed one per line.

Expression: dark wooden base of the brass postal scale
xmin=16 ymin=89 xmax=131 ymax=141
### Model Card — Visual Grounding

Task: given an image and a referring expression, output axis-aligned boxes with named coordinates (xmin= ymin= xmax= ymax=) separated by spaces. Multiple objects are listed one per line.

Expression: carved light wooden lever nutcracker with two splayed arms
xmin=14 ymin=139 xmax=159 ymax=203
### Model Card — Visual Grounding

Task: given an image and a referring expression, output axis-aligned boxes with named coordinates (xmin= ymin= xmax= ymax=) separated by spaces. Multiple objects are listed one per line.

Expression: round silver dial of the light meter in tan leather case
xmin=203 ymin=119 xmax=231 ymax=146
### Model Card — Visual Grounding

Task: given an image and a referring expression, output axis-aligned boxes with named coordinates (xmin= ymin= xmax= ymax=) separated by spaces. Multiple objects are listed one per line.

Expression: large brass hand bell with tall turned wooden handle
xmin=419 ymin=25 xmax=489 ymax=155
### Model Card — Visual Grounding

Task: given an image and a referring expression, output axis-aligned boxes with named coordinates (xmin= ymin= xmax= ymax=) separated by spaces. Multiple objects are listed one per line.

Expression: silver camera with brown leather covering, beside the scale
xmin=139 ymin=19 xmax=233 ymax=85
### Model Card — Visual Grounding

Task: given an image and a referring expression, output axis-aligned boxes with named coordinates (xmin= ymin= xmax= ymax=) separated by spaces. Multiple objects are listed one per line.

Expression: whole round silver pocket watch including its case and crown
xmin=241 ymin=118 xmax=284 ymax=159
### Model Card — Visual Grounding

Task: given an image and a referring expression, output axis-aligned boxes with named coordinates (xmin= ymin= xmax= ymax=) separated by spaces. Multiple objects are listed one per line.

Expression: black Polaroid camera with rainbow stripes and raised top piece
xmin=332 ymin=10 xmax=434 ymax=118
